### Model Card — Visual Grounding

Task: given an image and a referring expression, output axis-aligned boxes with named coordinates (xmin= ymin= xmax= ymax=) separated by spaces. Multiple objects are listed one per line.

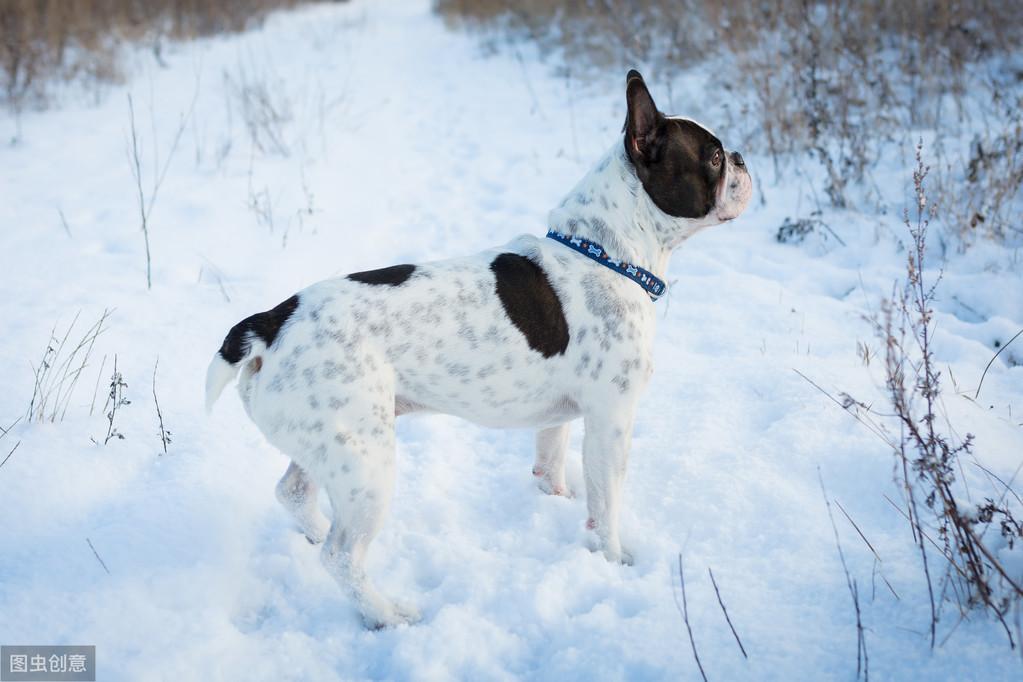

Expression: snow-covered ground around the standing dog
xmin=0 ymin=1 xmax=1023 ymax=680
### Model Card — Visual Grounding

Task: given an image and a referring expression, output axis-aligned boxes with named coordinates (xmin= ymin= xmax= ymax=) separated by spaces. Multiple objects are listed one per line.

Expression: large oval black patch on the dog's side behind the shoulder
xmin=490 ymin=254 xmax=569 ymax=358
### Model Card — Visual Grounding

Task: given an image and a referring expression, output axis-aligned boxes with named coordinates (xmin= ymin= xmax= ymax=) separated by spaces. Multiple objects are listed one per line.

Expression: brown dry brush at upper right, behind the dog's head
xmin=436 ymin=0 xmax=1023 ymax=245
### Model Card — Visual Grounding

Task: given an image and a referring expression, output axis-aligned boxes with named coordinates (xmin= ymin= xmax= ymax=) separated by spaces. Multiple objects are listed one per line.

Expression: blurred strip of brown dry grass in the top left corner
xmin=0 ymin=0 xmax=304 ymax=110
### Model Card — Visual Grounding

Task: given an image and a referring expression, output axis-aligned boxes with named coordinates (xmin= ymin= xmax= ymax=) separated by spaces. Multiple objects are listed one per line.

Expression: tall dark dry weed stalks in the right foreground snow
xmin=875 ymin=143 xmax=1023 ymax=647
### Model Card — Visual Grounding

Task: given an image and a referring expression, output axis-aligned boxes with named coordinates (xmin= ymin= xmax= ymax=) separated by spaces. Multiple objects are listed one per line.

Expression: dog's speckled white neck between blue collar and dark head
xmin=547 ymin=139 xmax=704 ymax=278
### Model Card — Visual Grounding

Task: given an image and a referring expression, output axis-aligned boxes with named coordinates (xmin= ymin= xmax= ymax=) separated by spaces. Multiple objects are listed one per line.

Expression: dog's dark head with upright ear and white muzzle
xmin=625 ymin=71 xmax=753 ymax=227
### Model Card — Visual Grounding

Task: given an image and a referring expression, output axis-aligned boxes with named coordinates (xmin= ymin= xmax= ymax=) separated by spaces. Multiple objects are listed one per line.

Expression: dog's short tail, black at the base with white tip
xmin=206 ymin=294 xmax=299 ymax=413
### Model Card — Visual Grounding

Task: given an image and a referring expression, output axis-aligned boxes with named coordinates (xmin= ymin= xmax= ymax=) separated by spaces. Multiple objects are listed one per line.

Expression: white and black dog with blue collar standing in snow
xmin=206 ymin=71 xmax=752 ymax=628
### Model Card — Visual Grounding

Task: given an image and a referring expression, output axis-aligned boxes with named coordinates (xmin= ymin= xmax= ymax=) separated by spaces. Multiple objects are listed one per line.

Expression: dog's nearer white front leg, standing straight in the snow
xmin=582 ymin=406 xmax=634 ymax=563
